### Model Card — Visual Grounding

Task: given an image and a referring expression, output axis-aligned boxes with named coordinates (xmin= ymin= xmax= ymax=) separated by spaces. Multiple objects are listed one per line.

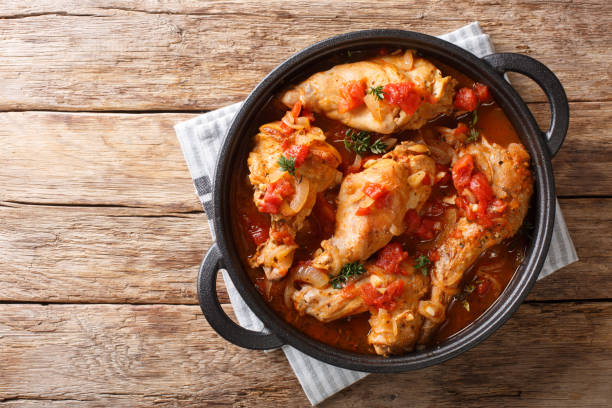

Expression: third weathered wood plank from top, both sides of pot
xmin=0 ymin=199 xmax=612 ymax=304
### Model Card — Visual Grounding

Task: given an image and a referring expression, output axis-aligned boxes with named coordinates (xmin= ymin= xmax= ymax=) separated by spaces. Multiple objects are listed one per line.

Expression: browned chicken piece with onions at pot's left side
xmin=248 ymin=122 xmax=342 ymax=280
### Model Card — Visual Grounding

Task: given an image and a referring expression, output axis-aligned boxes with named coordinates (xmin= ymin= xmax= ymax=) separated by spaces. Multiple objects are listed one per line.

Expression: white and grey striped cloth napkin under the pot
xmin=174 ymin=22 xmax=578 ymax=405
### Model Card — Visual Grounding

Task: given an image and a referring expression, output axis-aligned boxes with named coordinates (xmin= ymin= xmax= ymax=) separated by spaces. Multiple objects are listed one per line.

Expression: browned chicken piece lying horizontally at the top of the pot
xmin=281 ymin=50 xmax=456 ymax=134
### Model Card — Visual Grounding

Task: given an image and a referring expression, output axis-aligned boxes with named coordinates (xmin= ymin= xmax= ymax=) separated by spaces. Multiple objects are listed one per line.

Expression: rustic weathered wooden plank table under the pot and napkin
xmin=0 ymin=0 xmax=612 ymax=407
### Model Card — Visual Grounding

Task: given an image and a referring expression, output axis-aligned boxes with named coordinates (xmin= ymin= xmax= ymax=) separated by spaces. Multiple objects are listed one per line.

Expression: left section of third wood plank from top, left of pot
xmin=0 ymin=206 xmax=211 ymax=304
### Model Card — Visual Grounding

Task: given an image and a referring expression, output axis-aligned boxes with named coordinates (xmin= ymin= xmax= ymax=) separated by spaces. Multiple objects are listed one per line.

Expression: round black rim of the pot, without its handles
xmin=213 ymin=29 xmax=556 ymax=372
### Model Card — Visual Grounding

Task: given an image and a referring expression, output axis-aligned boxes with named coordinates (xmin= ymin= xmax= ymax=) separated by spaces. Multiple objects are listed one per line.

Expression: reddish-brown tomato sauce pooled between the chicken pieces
xmin=230 ymin=52 xmax=531 ymax=354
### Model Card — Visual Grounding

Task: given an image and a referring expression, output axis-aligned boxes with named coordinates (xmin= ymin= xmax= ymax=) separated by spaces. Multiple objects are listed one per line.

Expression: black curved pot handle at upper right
xmin=483 ymin=53 xmax=569 ymax=156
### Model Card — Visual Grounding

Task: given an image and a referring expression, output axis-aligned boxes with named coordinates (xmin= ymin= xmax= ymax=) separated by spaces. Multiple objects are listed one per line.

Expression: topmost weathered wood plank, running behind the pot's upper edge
xmin=0 ymin=0 xmax=612 ymax=110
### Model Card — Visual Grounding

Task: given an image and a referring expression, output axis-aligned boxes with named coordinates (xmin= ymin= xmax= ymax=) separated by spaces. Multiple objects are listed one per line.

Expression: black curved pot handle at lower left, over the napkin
xmin=198 ymin=243 xmax=283 ymax=350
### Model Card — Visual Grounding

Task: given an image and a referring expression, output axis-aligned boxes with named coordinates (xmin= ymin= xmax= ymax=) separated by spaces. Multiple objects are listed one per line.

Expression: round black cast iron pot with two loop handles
xmin=198 ymin=30 xmax=569 ymax=372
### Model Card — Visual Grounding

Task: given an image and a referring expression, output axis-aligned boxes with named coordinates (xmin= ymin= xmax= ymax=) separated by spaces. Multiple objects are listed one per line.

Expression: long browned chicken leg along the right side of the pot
xmin=419 ymin=140 xmax=533 ymax=344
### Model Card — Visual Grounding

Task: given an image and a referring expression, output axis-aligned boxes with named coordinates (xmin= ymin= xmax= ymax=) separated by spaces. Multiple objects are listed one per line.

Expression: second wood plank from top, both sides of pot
xmin=0 ymin=102 xmax=612 ymax=217
